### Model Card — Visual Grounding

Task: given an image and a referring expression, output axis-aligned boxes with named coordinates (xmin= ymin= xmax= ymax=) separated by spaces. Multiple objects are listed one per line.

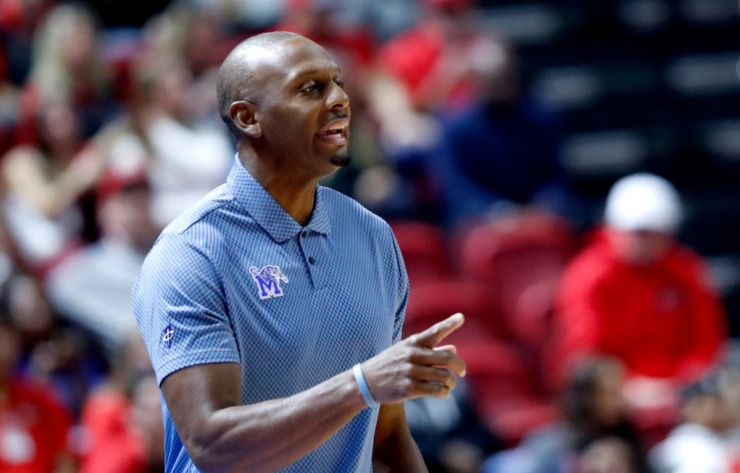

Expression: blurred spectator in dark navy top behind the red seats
xmin=427 ymin=38 xmax=571 ymax=226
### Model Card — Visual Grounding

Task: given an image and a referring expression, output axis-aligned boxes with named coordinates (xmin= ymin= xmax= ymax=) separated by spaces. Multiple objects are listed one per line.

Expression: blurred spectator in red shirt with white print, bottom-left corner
xmin=0 ymin=314 xmax=75 ymax=473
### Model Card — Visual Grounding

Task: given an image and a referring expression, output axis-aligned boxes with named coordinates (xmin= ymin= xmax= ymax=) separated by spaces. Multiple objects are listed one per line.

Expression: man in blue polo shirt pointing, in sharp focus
xmin=134 ymin=32 xmax=465 ymax=473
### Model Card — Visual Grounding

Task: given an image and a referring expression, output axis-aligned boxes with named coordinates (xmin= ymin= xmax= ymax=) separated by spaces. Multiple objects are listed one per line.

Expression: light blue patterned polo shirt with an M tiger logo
xmin=133 ymin=159 xmax=409 ymax=473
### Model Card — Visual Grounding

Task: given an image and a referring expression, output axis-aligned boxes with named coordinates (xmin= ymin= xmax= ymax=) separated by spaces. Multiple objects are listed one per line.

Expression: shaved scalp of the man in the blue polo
xmin=216 ymin=31 xmax=310 ymax=138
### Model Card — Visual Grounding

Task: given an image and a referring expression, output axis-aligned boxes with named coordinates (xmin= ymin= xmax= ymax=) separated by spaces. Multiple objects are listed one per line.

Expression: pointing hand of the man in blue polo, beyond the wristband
xmin=362 ymin=313 xmax=465 ymax=404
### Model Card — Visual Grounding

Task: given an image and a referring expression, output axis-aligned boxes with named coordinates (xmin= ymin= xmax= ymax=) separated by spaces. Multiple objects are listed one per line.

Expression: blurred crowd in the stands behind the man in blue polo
xmin=0 ymin=0 xmax=740 ymax=473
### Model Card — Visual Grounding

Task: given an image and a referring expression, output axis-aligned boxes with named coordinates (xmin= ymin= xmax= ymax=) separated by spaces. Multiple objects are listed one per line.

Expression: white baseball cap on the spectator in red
xmin=604 ymin=173 xmax=683 ymax=234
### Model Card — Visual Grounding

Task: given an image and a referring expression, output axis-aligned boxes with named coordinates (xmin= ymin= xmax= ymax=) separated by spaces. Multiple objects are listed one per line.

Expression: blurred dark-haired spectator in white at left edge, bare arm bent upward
xmin=0 ymin=101 xmax=110 ymax=276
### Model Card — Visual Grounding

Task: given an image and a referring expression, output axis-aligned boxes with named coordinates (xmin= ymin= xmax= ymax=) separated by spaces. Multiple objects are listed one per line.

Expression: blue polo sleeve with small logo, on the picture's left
xmin=132 ymin=230 xmax=239 ymax=384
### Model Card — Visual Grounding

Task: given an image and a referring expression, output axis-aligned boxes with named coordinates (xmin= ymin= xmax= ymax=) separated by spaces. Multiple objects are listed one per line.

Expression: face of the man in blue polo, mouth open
xmin=253 ymin=38 xmax=350 ymax=177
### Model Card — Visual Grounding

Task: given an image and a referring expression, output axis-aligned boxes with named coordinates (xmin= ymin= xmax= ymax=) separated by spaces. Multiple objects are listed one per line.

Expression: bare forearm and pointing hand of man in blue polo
xmin=162 ymin=315 xmax=465 ymax=473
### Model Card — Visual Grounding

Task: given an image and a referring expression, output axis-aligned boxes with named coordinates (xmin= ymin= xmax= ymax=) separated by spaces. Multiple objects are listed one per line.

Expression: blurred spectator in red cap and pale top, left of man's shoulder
xmin=46 ymin=170 xmax=161 ymax=353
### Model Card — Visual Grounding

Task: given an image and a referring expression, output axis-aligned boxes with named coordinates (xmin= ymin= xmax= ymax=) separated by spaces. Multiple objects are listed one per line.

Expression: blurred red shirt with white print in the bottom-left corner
xmin=0 ymin=382 xmax=71 ymax=473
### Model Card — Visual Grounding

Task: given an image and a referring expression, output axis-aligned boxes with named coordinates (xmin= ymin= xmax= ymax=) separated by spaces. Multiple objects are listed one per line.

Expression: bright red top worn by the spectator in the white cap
xmin=555 ymin=230 xmax=727 ymax=382
